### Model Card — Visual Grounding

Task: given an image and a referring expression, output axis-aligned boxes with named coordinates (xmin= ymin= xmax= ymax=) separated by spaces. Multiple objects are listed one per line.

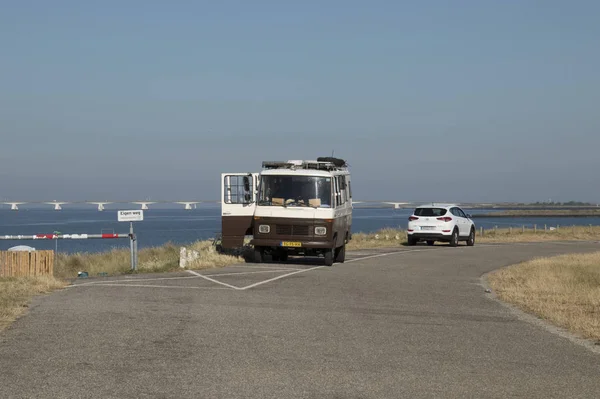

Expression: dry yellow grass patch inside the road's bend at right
xmin=488 ymin=252 xmax=600 ymax=340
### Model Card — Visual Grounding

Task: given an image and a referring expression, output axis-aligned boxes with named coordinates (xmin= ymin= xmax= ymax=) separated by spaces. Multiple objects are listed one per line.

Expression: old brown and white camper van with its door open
xmin=221 ymin=157 xmax=352 ymax=266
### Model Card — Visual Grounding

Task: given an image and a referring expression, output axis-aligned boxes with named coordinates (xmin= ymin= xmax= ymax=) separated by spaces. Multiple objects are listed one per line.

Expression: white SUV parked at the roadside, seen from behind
xmin=407 ymin=204 xmax=475 ymax=247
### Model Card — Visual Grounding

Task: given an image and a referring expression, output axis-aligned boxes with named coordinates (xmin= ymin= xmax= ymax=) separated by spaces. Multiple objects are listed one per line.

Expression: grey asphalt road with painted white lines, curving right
xmin=0 ymin=243 xmax=600 ymax=399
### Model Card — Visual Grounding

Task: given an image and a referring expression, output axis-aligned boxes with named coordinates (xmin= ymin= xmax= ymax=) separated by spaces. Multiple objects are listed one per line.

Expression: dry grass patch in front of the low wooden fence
xmin=0 ymin=276 xmax=66 ymax=331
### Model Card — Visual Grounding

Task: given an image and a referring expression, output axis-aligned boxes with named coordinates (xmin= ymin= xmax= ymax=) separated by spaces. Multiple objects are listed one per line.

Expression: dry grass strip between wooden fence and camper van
xmin=54 ymin=241 xmax=244 ymax=278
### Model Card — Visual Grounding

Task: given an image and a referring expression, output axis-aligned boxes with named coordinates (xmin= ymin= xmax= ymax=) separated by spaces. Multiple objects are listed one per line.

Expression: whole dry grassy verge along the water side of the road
xmin=0 ymin=227 xmax=600 ymax=330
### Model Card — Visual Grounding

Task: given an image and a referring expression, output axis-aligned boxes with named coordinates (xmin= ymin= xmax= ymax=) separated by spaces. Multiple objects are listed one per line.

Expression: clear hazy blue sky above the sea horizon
xmin=0 ymin=0 xmax=600 ymax=202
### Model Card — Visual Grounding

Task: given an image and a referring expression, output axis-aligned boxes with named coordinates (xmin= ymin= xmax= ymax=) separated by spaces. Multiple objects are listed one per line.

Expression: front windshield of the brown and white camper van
xmin=258 ymin=175 xmax=331 ymax=208
